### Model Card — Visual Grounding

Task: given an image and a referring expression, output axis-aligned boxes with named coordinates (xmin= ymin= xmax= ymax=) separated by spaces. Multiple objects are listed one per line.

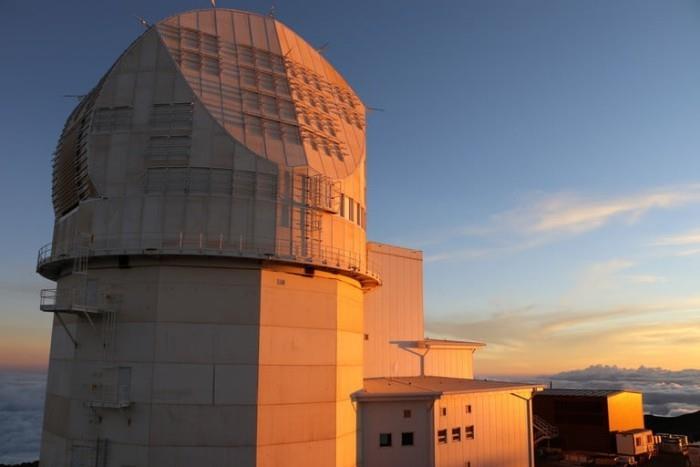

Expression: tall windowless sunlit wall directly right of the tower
xmin=364 ymin=242 xmax=423 ymax=378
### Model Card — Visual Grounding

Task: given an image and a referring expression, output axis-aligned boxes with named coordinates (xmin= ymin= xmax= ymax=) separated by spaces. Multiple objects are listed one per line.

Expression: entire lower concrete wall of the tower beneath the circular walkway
xmin=41 ymin=257 xmax=362 ymax=467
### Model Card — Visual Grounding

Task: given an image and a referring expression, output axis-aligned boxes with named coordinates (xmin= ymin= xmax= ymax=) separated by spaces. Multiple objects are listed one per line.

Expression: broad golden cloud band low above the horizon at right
xmin=426 ymin=296 xmax=700 ymax=373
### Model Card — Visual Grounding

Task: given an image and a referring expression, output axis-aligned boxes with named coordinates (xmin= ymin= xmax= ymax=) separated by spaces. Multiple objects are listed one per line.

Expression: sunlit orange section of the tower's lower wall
xmin=257 ymin=268 xmax=362 ymax=467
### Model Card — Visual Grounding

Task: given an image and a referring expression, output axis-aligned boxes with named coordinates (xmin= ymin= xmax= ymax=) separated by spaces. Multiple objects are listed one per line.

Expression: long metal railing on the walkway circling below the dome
xmin=37 ymin=233 xmax=380 ymax=283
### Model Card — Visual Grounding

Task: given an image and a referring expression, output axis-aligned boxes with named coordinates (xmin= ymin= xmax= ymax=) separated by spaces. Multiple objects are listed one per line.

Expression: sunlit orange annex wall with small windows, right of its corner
xmin=433 ymin=391 xmax=531 ymax=467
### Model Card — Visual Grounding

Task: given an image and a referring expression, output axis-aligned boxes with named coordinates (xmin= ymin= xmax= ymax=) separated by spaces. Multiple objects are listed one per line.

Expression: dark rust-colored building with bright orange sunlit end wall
xmin=533 ymin=389 xmax=644 ymax=453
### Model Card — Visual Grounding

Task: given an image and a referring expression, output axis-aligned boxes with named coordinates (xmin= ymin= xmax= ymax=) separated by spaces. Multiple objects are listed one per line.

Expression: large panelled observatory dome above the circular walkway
xmin=40 ymin=9 xmax=374 ymax=288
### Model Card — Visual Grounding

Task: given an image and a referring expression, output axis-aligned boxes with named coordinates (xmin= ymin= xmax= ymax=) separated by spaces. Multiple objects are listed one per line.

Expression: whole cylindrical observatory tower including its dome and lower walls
xmin=37 ymin=9 xmax=378 ymax=467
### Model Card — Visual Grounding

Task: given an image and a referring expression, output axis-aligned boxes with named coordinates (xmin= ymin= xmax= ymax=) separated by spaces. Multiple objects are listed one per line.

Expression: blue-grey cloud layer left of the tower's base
xmin=0 ymin=371 xmax=46 ymax=464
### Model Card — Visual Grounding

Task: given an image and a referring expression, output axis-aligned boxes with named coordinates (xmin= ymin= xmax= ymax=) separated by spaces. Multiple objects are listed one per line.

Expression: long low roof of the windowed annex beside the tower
xmin=353 ymin=376 xmax=542 ymax=400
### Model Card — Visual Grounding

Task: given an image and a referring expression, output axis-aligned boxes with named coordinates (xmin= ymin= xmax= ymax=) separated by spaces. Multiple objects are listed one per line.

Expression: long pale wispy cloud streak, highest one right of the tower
xmin=418 ymin=184 xmax=700 ymax=262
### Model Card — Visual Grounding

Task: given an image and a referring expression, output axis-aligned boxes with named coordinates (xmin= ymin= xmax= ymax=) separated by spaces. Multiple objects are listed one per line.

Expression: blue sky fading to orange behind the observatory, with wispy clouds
xmin=0 ymin=0 xmax=700 ymax=375
